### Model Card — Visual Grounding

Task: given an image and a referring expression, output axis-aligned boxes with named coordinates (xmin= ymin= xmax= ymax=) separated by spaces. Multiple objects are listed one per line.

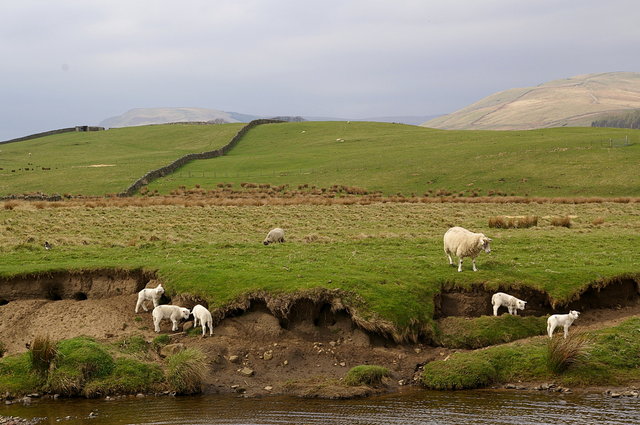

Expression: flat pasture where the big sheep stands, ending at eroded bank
xmin=0 ymin=203 xmax=640 ymax=333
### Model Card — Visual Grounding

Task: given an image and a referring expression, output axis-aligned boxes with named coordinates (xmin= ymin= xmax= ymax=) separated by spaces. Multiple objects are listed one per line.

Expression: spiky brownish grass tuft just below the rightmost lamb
xmin=545 ymin=332 xmax=593 ymax=374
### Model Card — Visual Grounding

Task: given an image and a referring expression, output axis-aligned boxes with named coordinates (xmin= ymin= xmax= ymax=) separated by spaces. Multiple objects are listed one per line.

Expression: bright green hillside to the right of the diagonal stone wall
xmin=149 ymin=122 xmax=640 ymax=196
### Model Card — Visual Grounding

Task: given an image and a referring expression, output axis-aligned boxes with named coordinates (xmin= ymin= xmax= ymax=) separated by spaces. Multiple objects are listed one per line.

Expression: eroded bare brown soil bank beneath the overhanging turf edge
xmin=0 ymin=270 xmax=640 ymax=398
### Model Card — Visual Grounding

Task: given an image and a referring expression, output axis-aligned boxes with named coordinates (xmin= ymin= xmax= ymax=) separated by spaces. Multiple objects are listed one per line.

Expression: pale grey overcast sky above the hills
xmin=0 ymin=0 xmax=640 ymax=140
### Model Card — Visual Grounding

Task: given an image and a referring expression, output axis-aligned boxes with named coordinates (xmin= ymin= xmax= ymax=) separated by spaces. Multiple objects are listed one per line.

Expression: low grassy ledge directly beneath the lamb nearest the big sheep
xmin=437 ymin=314 xmax=546 ymax=349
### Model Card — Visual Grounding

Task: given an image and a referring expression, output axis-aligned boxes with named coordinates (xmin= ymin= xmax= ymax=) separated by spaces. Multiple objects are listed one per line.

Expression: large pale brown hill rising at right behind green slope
xmin=422 ymin=72 xmax=640 ymax=130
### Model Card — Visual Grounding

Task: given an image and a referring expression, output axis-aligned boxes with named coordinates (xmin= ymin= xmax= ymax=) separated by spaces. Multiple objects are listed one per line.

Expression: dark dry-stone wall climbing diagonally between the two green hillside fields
xmin=118 ymin=119 xmax=284 ymax=197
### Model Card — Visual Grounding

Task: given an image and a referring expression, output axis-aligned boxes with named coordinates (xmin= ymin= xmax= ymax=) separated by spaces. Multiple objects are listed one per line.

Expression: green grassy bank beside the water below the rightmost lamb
xmin=421 ymin=317 xmax=640 ymax=389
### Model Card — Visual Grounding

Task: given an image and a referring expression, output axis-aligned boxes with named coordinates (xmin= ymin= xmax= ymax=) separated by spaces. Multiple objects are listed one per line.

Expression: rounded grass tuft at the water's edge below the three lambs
xmin=167 ymin=348 xmax=207 ymax=394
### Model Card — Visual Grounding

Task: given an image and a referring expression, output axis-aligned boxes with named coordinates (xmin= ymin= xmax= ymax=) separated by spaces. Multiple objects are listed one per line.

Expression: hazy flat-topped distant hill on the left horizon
xmin=100 ymin=108 xmax=244 ymax=128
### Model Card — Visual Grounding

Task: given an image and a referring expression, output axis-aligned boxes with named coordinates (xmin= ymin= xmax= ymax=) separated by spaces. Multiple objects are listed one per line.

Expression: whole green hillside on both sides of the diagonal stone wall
xmin=0 ymin=122 xmax=640 ymax=197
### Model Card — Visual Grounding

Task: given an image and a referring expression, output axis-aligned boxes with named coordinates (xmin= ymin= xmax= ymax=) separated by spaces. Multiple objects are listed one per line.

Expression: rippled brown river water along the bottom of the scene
xmin=0 ymin=391 xmax=640 ymax=425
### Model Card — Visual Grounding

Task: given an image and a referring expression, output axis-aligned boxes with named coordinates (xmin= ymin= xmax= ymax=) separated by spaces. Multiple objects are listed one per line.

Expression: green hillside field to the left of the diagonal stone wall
xmin=0 ymin=124 xmax=244 ymax=196
